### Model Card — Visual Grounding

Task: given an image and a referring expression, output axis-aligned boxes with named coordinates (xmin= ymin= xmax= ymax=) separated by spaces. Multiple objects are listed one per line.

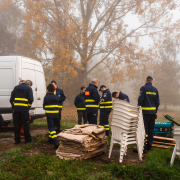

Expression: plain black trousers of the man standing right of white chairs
xmin=143 ymin=114 xmax=156 ymax=150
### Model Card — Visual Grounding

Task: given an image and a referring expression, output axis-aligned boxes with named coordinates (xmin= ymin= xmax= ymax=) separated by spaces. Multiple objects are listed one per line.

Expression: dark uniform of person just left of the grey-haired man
xmin=74 ymin=93 xmax=87 ymax=125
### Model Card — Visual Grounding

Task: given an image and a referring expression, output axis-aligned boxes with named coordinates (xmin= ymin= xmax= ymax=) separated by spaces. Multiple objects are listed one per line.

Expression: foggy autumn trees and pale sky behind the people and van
xmin=0 ymin=0 xmax=180 ymax=122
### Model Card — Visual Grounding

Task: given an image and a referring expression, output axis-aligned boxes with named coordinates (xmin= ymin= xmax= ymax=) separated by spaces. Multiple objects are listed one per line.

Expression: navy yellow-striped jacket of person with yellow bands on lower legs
xmin=43 ymin=93 xmax=59 ymax=118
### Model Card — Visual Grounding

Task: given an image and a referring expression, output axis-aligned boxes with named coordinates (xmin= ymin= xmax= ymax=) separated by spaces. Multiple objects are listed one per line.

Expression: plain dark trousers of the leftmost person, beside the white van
xmin=14 ymin=111 xmax=32 ymax=142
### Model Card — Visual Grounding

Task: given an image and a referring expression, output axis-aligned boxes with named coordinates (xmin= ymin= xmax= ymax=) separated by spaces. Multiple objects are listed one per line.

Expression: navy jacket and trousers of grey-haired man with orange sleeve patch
xmin=85 ymin=84 xmax=100 ymax=124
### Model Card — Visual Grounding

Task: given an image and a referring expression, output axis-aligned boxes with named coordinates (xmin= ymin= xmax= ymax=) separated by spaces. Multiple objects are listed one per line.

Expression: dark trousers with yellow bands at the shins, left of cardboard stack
xmin=47 ymin=118 xmax=58 ymax=145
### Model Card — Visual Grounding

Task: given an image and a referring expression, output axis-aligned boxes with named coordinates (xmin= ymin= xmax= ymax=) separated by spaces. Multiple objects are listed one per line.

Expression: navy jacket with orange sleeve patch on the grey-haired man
xmin=85 ymin=84 xmax=100 ymax=112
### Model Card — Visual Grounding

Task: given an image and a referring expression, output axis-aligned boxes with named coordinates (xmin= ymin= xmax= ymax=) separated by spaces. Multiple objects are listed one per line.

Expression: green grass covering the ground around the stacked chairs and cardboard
xmin=0 ymin=114 xmax=180 ymax=180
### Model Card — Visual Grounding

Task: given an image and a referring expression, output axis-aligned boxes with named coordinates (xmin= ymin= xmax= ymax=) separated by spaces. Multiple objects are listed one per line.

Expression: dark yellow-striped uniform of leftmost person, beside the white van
xmin=10 ymin=83 xmax=33 ymax=143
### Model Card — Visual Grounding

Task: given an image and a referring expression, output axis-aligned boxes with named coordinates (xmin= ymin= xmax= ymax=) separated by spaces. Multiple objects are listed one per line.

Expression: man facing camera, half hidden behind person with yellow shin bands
xmin=51 ymin=81 xmax=66 ymax=133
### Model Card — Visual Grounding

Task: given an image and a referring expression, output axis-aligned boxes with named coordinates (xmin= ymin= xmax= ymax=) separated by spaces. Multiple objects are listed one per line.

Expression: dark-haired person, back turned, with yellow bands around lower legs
xmin=43 ymin=84 xmax=59 ymax=148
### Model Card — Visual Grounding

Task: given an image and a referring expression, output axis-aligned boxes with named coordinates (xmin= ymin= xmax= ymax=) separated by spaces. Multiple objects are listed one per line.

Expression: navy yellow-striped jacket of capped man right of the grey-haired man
xmin=100 ymin=89 xmax=112 ymax=111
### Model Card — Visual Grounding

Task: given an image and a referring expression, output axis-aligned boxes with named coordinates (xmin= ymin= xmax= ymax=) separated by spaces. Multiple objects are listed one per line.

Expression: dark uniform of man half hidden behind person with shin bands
xmin=55 ymin=88 xmax=66 ymax=133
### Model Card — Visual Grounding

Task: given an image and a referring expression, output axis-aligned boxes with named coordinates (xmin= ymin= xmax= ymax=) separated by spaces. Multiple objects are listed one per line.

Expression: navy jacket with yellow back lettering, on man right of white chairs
xmin=138 ymin=82 xmax=160 ymax=114
